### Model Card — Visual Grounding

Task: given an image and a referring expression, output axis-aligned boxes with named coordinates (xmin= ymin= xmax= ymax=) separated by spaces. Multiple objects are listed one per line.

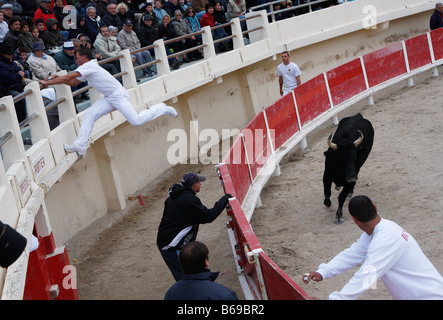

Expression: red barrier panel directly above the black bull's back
xmin=326 ymin=59 xmax=367 ymax=106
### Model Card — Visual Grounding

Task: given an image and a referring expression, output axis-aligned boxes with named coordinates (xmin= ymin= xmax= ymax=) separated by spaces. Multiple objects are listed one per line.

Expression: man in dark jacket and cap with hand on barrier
xmin=157 ymin=172 xmax=231 ymax=281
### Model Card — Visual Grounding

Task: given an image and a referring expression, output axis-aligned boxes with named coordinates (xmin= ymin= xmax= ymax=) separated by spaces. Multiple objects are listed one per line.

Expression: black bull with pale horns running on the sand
xmin=323 ymin=113 xmax=374 ymax=223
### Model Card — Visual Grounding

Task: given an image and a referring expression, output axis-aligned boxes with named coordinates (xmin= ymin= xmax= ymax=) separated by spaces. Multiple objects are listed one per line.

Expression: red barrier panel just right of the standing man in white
xmin=294 ymin=74 xmax=331 ymax=126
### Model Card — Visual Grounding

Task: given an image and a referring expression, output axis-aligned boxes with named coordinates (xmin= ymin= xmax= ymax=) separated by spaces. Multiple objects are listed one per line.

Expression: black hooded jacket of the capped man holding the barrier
xmin=157 ymin=184 xmax=231 ymax=250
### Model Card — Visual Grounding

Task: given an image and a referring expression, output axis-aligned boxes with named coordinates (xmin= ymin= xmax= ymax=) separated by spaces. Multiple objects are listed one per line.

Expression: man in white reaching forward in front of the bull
xmin=303 ymin=196 xmax=443 ymax=300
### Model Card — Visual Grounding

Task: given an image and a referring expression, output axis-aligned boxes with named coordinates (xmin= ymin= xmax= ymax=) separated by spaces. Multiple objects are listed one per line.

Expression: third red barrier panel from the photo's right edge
xmin=363 ymin=42 xmax=407 ymax=88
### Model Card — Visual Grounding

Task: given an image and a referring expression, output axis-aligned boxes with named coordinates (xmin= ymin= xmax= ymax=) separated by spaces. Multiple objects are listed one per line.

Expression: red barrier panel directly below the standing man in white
xmin=265 ymin=93 xmax=300 ymax=150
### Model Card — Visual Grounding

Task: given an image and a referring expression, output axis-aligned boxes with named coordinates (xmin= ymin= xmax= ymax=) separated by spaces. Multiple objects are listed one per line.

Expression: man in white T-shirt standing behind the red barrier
xmin=277 ymin=51 xmax=301 ymax=96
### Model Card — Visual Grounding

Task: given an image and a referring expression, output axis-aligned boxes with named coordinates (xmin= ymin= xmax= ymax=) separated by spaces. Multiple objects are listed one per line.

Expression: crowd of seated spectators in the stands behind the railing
xmin=0 ymin=0 xmax=346 ymax=127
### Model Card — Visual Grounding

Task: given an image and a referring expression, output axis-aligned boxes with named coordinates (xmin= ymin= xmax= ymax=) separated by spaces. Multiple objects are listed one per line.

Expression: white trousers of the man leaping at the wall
xmin=74 ymin=91 xmax=168 ymax=150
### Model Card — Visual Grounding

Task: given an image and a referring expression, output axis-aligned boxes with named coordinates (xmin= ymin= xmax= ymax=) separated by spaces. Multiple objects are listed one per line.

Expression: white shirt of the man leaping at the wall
xmin=75 ymin=60 xmax=125 ymax=97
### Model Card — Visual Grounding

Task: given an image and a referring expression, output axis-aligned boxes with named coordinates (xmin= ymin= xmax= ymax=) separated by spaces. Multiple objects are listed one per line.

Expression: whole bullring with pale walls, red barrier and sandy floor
xmin=0 ymin=0 xmax=443 ymax=300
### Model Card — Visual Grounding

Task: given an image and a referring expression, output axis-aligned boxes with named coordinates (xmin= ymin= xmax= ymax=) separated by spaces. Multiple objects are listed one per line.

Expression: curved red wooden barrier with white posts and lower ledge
xmin=217 ymin=28 xmax=443 ymax=299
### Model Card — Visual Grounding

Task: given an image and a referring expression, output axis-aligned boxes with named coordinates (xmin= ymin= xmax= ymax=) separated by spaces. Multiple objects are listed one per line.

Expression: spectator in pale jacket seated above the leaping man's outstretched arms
xmin=28 ymin=41 xmax=61 ymax=80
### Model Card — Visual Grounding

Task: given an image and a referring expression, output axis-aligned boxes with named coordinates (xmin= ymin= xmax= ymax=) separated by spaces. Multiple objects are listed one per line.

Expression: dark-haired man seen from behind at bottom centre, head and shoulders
xmin=165 ymin=241 xmax=238 ymax=300
